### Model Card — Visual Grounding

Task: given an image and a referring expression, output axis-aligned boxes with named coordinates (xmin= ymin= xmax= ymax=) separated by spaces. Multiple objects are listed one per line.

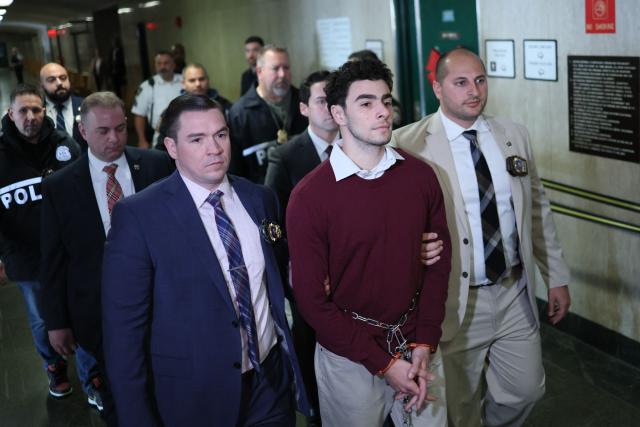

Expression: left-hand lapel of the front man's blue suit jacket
xmin=166 ymin=171 xmax=236 ymax=314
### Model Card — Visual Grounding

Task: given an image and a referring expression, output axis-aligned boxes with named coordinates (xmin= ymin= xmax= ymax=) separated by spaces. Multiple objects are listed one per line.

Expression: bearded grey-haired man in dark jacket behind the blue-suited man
xmin=229 ymin=45 xmax=308 ymax=184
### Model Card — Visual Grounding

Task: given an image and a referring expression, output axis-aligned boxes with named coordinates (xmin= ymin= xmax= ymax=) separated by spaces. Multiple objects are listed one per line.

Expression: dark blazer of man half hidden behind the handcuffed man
xmin=264 ymin=130 xmax=320 ymax=217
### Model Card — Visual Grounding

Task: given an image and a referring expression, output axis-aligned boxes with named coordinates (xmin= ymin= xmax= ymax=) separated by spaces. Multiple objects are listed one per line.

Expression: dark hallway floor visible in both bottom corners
xmin=0 ymin=284 xmax=640 ymax=427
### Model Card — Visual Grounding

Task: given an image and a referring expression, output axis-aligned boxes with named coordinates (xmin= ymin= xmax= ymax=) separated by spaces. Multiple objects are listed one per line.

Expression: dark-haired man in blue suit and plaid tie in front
xmin=102 ymin=95 xmax=309 ymax=427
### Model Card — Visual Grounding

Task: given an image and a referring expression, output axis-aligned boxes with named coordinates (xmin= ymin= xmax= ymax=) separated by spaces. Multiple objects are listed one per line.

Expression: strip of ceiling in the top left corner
xmin=0 ymin=0 xmax=117 ymax=30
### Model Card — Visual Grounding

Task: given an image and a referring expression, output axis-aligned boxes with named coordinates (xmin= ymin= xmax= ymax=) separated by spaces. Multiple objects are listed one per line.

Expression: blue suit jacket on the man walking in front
xmin=102 ymin=172 xmax=308 ymax=427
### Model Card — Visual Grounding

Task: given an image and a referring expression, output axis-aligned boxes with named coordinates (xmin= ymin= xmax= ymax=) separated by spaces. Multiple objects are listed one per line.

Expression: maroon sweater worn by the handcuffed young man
xmin=287 ymin=150 xmax=451 ymax=374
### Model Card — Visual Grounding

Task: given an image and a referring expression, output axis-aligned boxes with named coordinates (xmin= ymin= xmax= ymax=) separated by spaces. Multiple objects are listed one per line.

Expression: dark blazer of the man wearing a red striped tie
xmin=41 ymin=147 xmax=173 ymax=352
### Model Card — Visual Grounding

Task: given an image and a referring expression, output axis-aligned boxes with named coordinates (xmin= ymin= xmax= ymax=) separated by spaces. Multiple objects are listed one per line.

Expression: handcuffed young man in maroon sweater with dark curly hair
xmin=287 ymin=61 xmax=451 ymax=427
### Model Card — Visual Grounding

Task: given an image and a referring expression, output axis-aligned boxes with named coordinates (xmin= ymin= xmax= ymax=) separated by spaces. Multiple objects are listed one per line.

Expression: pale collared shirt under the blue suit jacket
xmin=180 ymin=174 xmax=277 ymax=372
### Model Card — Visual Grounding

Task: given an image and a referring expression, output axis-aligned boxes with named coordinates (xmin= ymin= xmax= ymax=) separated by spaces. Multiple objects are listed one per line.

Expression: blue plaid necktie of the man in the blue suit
xmin=207 ymin=190 xmax=260 ymax=372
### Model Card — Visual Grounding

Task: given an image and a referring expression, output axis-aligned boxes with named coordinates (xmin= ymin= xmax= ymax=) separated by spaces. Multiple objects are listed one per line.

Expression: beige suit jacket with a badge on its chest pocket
xmin=392 ymin=113 xmax=569 ymax=342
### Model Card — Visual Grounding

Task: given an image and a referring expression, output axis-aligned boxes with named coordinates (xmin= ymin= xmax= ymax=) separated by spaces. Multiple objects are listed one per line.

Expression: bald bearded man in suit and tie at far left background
xmin=40 ymin=62 xmax=87 ymax=152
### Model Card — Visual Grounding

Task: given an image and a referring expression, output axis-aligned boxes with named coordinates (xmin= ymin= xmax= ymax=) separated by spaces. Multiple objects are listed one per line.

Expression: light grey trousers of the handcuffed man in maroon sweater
xmin=315 ymin=344 xmax=447 ymax=427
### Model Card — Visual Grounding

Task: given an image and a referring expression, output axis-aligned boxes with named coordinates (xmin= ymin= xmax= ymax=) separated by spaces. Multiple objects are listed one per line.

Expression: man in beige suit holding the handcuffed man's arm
xmin=394 ymin=48 xmax=570 ymax=427
